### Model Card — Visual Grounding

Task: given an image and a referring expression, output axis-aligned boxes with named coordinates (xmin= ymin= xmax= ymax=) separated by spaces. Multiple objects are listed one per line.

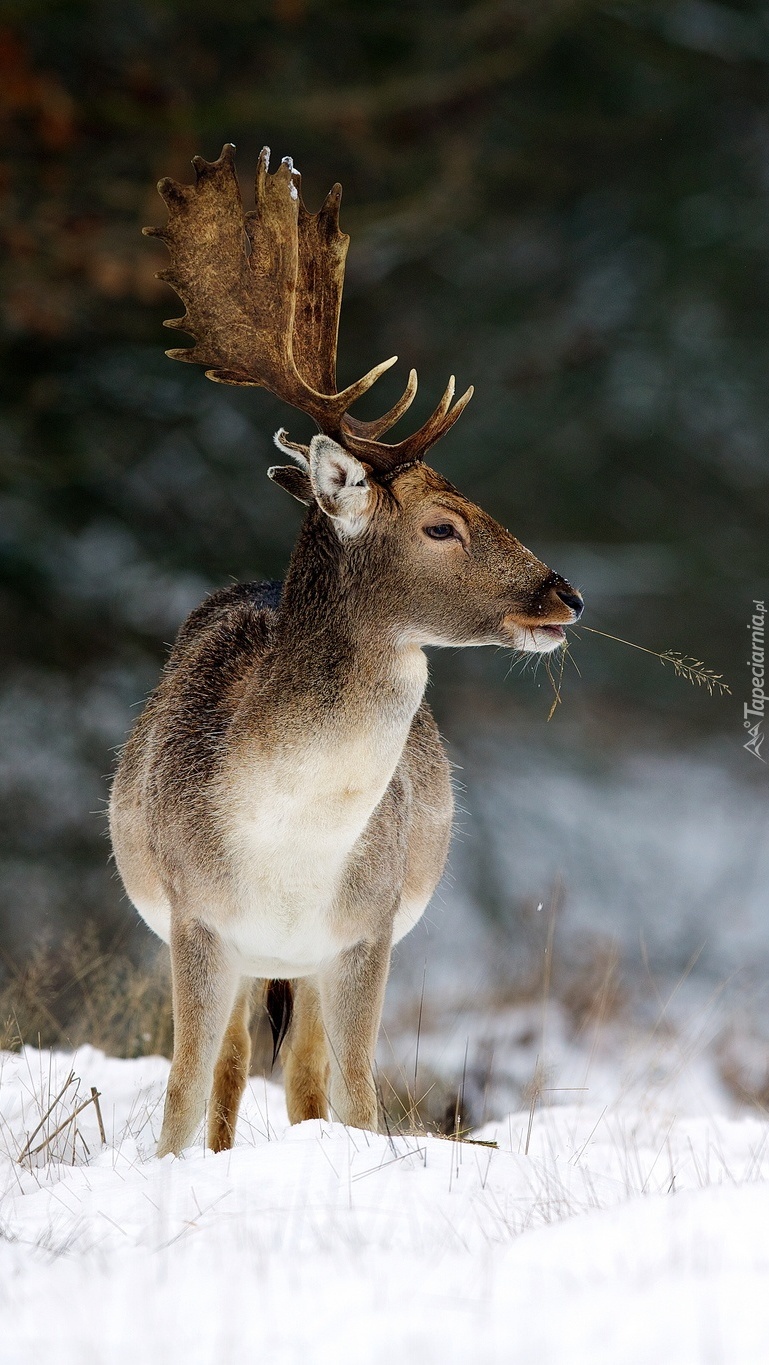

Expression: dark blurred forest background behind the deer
xmin=0 ymin=0 xmax=769 ymax=1064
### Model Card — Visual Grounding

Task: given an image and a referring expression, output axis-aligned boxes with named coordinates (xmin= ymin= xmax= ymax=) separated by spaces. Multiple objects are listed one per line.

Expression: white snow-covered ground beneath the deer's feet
xmin=0 ymin=1048 xmax=769 ymax=1365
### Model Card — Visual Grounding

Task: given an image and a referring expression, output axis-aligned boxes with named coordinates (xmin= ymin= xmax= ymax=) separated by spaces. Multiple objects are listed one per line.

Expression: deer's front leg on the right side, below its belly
xmin=318 ymin=927 xmax=391 ymax=1133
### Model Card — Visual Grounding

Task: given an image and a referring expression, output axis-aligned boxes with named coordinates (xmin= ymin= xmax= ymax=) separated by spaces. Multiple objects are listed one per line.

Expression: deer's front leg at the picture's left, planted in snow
xmin=157 ymin=920 xmax=238 ymax=1156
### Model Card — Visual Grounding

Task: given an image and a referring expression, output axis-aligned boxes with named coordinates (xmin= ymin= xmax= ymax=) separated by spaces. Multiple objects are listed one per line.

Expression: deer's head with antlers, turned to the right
xmin=145 ymin=145 xmax=582 ymax=652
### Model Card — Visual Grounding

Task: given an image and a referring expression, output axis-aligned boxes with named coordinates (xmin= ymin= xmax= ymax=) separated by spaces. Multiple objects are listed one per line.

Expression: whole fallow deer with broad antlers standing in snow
xmin=111 ymin=145 xmax=582 ymax=1155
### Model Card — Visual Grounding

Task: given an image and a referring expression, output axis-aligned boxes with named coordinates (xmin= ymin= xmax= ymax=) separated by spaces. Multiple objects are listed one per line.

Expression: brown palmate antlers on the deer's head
xmin=143 ymin=143 xmax=473 ymax=476
